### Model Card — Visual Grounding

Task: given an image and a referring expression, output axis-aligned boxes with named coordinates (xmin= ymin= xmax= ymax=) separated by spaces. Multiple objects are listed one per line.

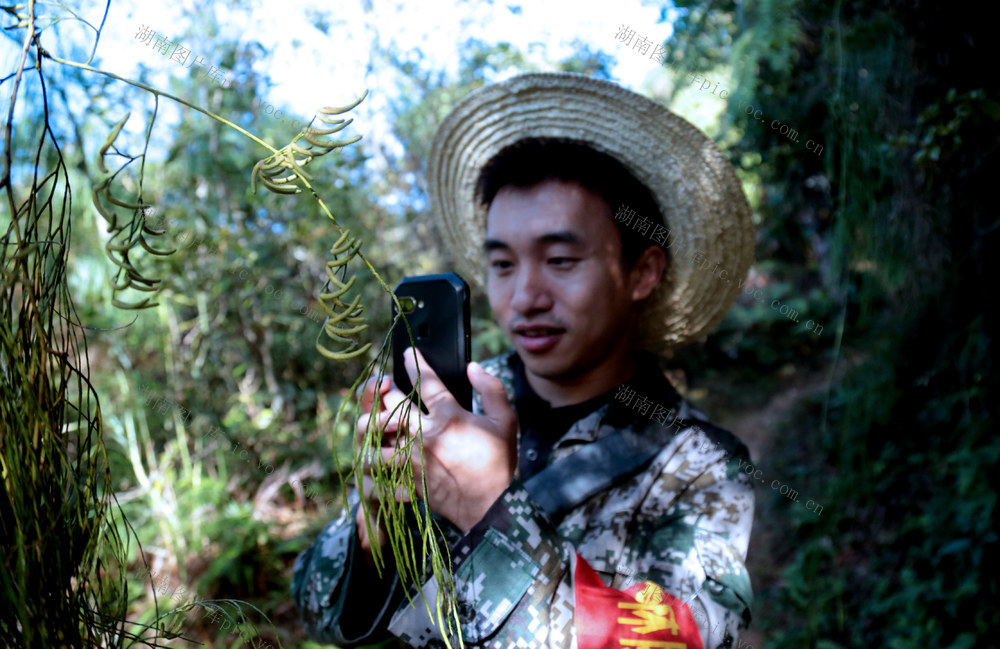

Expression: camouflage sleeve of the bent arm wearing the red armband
xmin=390 ymin=426 xmax=753 ymax=649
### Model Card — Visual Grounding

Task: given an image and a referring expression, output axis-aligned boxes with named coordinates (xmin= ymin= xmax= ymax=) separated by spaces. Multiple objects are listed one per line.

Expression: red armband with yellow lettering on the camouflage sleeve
xmin=573 ymin=554 xmax=702 ymax=649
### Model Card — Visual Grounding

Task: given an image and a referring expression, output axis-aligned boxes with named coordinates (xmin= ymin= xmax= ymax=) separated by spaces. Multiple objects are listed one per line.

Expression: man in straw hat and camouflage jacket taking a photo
xmin=293 ymin=74 xmax=753 ymax=649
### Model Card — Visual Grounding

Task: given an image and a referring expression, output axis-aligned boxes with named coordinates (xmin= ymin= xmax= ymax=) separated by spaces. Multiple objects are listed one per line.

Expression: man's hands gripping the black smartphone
xmin=358 ymin=347 xmax=517 ymax=543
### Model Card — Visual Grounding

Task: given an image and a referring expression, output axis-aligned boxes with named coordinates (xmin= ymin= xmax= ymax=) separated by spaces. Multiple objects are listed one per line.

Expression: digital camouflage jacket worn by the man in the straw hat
xmin=292 ymin=353 xmax=754 ymax=649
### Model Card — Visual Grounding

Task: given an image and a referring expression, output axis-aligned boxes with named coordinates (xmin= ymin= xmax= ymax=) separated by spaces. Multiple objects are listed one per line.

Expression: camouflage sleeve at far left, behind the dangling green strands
xmin=292 ymin=492 xmax=403 ymax=647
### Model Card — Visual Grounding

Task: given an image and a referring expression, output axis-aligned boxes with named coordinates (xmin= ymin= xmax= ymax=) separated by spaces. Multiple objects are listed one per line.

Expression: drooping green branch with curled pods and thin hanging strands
xmin=0 ymin=0 xmax=462 ymax=647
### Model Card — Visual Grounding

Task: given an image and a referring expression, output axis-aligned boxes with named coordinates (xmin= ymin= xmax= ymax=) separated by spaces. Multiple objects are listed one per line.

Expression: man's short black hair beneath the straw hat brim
xmin=476 ymin=138 xmax=670 ymax=268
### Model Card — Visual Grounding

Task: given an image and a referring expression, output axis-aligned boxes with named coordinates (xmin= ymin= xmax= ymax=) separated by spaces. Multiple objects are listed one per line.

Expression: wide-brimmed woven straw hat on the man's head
xmin=427 ymin=73 xmax=754 ymax=351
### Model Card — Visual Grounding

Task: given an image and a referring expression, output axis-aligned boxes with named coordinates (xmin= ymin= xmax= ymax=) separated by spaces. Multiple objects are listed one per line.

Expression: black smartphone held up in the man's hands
xmin=392 ymin=273 xmax=472 ymax=412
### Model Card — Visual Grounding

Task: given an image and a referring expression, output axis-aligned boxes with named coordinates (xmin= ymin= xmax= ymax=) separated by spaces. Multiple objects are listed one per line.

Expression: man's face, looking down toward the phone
xmin=485 ymin=180 xmax=648 ymax=382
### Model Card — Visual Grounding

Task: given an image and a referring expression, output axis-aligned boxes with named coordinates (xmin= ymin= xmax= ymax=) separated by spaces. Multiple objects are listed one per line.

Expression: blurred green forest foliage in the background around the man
xmin=0 ymin=0 xmax=1000 ymax=649
